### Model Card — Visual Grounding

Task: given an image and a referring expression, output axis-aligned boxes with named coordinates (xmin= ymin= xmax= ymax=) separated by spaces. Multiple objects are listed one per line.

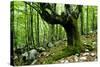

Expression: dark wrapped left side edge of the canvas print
xmin=10 ymin=1 xmax=16 ymax=65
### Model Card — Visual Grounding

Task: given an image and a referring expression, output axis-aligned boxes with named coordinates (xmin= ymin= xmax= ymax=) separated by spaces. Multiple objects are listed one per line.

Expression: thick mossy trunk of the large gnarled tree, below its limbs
xmin=63 ymin=20 xmax=81 ymax=53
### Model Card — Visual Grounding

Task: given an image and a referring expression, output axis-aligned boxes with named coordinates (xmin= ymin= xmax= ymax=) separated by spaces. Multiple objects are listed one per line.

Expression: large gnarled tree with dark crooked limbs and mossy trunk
xmin=25 ymin=2 xmax=82 ymax=51
